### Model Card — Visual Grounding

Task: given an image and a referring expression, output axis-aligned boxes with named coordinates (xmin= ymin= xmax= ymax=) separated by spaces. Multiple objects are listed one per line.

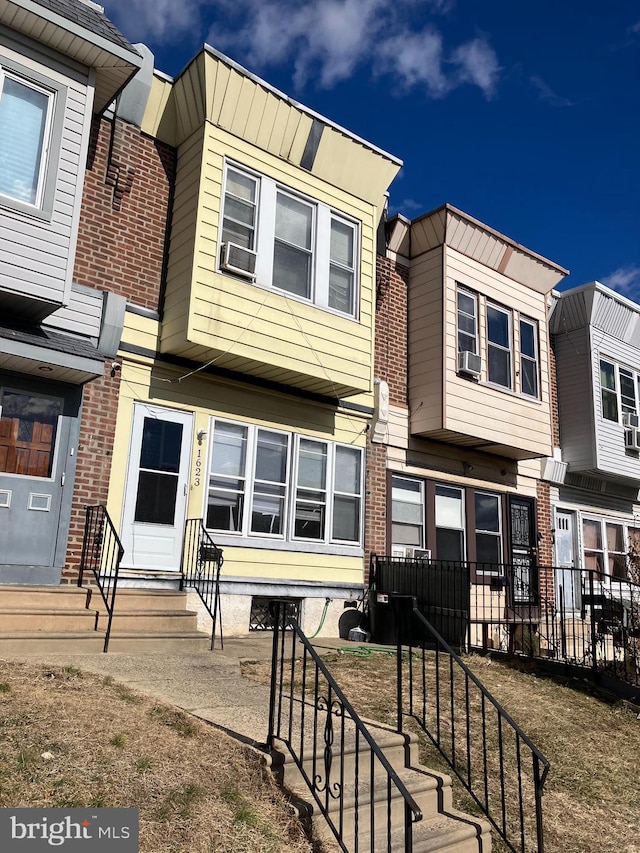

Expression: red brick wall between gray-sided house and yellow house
xmin=62 ymin=119 xmax=175 ymax=583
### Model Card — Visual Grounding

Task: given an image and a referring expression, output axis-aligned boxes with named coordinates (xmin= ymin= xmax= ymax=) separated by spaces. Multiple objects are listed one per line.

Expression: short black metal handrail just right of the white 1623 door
xmin=180 ymin=518 xmax=224 ymax=649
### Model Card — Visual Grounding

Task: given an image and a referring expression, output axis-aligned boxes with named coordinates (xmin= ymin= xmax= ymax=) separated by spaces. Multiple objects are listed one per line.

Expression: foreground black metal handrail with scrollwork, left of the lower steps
xmin=267 ymin=601 xmax=422 ymax=853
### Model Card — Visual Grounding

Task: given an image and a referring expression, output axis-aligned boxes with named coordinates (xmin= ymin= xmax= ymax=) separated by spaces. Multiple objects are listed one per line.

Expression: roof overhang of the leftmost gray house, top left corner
xmin=0 ymin=0 xmax=142 ymax=113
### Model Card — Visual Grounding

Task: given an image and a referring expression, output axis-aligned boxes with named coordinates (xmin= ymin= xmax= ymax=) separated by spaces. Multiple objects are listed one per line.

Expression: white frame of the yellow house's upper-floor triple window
xmin=216 ymin=161 xmax=361 ymax=319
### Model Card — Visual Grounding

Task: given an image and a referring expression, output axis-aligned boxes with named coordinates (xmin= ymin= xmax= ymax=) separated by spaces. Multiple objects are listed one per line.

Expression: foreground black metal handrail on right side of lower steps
xmin=392 ymin=596 xmax=549 ymax=853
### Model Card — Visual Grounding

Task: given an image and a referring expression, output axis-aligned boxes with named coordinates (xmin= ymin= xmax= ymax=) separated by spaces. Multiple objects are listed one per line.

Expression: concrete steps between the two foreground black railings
xmin=270 ymin=722 xmax=491 ymax=853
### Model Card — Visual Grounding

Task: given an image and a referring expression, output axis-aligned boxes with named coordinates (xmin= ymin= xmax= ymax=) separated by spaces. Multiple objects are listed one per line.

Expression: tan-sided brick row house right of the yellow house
xmin=367 ymin=205 xmax=567 ymax=644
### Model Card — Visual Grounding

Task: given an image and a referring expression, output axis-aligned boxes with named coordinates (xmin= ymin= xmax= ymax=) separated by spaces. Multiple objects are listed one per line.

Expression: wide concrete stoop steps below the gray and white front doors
xmin=0 ymin=586 xmax=211 ymax=654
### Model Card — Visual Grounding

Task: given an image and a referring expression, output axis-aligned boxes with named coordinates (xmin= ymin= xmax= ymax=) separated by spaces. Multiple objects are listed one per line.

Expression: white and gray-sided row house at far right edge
xmin=549 ymin=282 xmax=640 ymax=609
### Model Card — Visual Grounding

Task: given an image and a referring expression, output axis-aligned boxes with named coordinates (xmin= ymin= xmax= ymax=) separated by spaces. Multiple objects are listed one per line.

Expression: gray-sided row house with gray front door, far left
xmin=0 ymin=0 xmax=142 ymax=585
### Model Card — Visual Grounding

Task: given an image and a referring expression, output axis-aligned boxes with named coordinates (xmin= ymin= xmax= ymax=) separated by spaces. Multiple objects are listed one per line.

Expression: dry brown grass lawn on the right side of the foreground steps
xmin=245 ymin=654 xmax=640 ymax=853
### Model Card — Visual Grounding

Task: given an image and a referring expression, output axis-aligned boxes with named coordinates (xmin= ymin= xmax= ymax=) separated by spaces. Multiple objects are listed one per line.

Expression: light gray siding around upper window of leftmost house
xmin=0 ymin=31 xmax=92 ymax=316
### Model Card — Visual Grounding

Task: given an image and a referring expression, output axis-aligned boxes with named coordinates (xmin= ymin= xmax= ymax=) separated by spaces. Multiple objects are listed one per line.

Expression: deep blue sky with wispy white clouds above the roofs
xmin=103 ymin=0 xmax=640 ymax=302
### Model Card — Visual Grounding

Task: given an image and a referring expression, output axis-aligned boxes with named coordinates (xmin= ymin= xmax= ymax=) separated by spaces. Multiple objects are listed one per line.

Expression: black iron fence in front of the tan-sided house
xmin=369 ymin=556 xmax=640 ymax=688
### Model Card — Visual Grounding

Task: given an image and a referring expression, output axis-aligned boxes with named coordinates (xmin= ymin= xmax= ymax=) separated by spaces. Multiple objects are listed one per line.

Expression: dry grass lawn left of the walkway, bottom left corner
xmin=0 ymin=661 xmax=312 ymax=853
